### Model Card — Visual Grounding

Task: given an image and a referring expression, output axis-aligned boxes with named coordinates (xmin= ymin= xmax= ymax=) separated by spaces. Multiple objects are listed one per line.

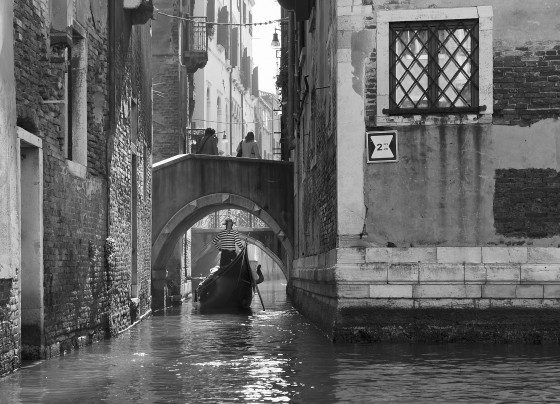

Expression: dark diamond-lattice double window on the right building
xmin=387 ymin=20 xmax=478 ymax=114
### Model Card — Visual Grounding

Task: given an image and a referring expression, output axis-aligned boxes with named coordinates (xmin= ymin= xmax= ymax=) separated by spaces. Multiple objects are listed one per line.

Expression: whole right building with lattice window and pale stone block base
xmin=279 ymin=0 xmax=560 ymax=342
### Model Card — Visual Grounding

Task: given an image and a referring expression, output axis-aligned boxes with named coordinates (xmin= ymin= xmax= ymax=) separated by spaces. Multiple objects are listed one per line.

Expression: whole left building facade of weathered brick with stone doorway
xmin=0 ymin=0 xmax=153 ymax=374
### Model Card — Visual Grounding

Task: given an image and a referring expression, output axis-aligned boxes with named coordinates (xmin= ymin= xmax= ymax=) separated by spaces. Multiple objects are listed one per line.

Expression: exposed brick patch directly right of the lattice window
xmin=493 ymin=40 xmax=560 ymax=126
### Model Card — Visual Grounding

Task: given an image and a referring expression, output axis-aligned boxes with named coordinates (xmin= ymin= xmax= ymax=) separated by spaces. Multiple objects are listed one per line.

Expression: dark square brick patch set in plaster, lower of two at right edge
xmin=494 ymin=169 xmax=560 ymax=238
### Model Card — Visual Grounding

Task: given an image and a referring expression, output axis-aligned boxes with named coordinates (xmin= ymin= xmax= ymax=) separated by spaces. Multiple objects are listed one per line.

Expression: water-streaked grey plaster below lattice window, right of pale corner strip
xmin=364 ymin=119 xmax=560 ymax=247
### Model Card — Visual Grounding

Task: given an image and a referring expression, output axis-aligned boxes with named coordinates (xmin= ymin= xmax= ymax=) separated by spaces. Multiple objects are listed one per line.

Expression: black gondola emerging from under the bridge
xmin=196 ymin=248 xmax=254 ymax=311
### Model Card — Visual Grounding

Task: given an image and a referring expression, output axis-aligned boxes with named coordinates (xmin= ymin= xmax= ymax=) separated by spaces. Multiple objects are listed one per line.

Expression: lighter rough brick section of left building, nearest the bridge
xmin=109 ymin=9 xmax=152 ymax=335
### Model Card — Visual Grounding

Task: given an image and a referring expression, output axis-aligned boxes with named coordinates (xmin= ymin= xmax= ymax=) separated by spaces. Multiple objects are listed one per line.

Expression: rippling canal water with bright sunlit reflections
xmin=0 ymin=274 xmax=560 ymax=404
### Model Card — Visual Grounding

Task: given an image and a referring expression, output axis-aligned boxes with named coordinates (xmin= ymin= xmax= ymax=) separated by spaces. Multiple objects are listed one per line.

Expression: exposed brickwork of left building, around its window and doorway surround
xmin=9 ymin=0 xmax=151 ymax=357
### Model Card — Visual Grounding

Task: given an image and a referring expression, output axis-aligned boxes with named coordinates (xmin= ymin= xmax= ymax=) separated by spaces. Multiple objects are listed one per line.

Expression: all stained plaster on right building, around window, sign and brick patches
xmin=337 ymin=1 xmax=560 ymax=247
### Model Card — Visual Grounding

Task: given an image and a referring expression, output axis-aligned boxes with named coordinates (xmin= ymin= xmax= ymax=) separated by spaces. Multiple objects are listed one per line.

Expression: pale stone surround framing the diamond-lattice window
xmin=376 ymin=6 xmax=493 ymax=125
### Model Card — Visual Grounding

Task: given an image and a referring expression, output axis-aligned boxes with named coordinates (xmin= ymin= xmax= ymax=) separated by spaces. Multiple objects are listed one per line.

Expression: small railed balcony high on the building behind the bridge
xmin=183 ymin=17 xmax=209 ymax=73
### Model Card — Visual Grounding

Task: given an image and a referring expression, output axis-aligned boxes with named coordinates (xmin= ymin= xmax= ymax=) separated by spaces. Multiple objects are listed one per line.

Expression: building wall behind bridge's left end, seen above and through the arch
xmin=152 ymin=0 xmax=208 ymax=309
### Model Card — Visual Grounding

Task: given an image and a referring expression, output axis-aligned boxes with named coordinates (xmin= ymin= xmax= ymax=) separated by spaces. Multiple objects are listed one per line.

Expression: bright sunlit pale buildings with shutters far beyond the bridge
xmin=191 ymin=0 xmax=259 ymax=156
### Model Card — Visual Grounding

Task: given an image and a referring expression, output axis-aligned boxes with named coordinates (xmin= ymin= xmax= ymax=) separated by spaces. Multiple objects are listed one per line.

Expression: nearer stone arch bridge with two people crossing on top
xmin=152 ymin=154 xmax=294 ymax=308
